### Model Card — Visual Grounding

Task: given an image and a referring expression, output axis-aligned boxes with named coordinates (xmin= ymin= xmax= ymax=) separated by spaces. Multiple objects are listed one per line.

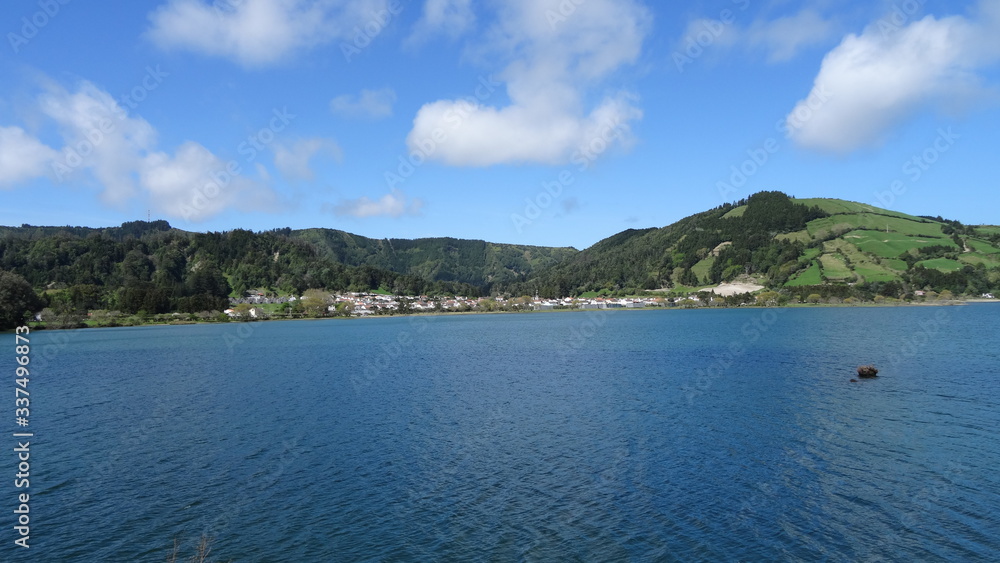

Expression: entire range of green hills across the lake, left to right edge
xmin=0 ymin=192 xmax=1000 ymax=312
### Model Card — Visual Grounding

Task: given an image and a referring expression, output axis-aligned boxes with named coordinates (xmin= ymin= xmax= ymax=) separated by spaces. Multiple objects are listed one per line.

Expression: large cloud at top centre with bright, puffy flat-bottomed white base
xmin=407 ymin=0 xmax=651 ymax=166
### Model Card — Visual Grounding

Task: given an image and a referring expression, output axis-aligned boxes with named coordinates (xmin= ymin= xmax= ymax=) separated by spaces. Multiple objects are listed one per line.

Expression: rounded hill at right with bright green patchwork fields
xmin=515 ymin=192 xmax=1000 ymax=297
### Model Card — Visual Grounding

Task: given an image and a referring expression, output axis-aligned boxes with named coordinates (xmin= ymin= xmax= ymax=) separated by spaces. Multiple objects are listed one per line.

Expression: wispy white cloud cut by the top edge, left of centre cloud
xmin=147 ymin=0 xmax=387 ymax=66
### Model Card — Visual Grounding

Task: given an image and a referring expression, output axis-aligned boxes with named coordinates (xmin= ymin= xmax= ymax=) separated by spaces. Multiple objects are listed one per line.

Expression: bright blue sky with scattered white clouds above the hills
xmin=0 ymin=0 xmax=1000 ymax=248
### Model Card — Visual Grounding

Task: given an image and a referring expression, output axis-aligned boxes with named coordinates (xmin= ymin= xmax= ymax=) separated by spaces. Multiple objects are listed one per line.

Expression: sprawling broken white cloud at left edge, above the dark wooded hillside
xmin=0 ymin=82 xmax=275 ymax=221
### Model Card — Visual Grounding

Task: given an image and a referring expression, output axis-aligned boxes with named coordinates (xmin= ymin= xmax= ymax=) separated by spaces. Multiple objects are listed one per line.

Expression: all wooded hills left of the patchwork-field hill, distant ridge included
xmin=0 ymin=221 xmax=578 ymax=314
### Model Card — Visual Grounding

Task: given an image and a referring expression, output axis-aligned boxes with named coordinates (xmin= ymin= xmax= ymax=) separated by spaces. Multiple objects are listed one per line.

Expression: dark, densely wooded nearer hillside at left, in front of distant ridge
xmin=0 ymin=221 xmax=480 ymax=320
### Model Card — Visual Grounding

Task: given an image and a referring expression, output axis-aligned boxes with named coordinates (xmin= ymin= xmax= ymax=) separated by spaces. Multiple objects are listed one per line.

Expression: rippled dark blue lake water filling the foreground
xmin=7 ymin=304 xmax=1000 ymax=561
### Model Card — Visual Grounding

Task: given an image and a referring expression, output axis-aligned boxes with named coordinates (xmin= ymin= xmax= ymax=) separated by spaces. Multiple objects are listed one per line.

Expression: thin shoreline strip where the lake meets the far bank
xmin=7 ymin=298 xmax=1000 ymax=333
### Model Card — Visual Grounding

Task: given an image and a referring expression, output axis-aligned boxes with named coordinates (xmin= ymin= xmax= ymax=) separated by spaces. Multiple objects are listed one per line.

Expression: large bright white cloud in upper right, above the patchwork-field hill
xmin=786 ymin=0 xmax=1000 ymax=153
